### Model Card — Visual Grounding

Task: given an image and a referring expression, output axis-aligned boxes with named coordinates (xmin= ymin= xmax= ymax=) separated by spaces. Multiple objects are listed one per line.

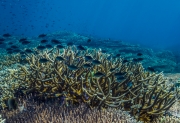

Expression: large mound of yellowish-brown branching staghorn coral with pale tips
xmin=1 ymin=46 xmax=178 ymax=121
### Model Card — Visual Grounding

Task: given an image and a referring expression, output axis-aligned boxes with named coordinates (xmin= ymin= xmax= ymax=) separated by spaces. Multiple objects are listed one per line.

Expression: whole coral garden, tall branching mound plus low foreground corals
xmin=0 ymin=32 xmax=179 ymax=123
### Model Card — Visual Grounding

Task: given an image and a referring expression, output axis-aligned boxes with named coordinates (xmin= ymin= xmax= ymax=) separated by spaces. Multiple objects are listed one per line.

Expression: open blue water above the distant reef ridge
xmin=0 ymin=0 xmax=180 ymax=52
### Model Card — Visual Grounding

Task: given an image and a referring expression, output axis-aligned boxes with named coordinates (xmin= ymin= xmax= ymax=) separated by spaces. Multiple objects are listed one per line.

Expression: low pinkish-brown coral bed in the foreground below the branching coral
xmin=2 ymin=96 xmax=141 ymax=123
